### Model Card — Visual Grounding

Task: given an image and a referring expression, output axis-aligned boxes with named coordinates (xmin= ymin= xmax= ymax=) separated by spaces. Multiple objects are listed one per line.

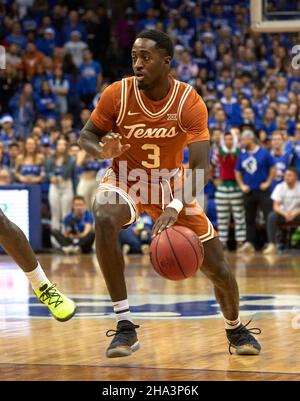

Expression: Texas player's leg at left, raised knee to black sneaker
xmin=93 ymin=189 xmax=139 ymax=358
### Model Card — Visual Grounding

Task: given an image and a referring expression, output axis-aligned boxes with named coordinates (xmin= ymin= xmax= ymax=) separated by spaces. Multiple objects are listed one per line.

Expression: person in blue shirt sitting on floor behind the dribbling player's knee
xmin=52 ymin=196 xmax=95 ymax=255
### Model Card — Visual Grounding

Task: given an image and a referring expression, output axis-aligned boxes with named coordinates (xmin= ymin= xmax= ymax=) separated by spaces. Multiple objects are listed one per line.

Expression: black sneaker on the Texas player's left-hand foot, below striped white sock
xmin=106 ymin=320 xmax=140 ymax=358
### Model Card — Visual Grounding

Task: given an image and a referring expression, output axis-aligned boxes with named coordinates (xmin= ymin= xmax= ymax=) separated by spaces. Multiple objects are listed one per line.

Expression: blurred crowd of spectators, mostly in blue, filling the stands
xmin=0 ymin=0 xmax=300 ymax=253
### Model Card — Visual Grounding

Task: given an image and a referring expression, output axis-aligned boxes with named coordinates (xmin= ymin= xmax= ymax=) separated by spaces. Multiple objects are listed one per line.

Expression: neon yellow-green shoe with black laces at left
xmin=35 ymin=282 xmax=76 ymax=322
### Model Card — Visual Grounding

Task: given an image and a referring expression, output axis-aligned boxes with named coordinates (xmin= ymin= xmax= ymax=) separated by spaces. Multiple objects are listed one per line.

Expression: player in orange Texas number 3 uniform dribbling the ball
xmin=79 ymin=30 xmax=261 ymax=358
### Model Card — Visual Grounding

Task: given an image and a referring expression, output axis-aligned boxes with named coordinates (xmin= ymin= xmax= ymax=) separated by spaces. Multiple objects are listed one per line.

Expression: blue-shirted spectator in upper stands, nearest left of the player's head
xmin=79 ymin=49 xmax=102 ymax=107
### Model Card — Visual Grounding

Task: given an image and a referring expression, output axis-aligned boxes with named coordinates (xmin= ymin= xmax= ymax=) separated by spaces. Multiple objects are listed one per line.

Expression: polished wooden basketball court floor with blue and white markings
xmin=0 ymin=253 xmax=300 ymax=380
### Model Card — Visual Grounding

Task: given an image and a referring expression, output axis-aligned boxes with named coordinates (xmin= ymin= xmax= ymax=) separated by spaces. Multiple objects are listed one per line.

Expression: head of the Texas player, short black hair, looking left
xmin=131 ymin=29 xmax=174 ymax=89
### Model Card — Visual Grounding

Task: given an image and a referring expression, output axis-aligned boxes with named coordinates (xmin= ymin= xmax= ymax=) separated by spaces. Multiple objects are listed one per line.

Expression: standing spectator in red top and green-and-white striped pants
xmin=215 ymin=131 xmax=246 ymax=248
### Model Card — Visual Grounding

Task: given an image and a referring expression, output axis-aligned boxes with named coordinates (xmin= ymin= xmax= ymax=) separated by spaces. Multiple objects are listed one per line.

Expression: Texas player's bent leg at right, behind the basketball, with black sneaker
xmin=176 ymin=202 xmax=261 ymax=355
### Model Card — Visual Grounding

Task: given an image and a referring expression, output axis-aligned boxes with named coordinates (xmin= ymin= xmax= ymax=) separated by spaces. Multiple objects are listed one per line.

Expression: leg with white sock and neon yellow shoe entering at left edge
xmin=0 ymin=209 xmax=76 ymax=322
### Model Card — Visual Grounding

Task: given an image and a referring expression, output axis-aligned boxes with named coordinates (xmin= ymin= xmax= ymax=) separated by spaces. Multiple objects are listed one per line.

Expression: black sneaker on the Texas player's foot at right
xmin=226 ymin=320 xmax=261 ymax=355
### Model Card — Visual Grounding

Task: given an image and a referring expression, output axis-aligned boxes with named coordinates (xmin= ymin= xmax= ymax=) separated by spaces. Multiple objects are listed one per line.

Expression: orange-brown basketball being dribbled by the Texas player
xmin=150 ymin=226 xmax=204 ymax=281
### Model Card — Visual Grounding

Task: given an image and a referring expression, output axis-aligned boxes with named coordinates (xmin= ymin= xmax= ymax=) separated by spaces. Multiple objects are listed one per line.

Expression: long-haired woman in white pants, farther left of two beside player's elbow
xmin=45 ymin=138 xmax=75 ymax=230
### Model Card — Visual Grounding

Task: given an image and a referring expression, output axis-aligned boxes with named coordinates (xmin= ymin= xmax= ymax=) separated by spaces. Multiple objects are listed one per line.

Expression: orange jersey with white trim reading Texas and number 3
xmin=91 ymin=76 xmax=209 ymax=174
